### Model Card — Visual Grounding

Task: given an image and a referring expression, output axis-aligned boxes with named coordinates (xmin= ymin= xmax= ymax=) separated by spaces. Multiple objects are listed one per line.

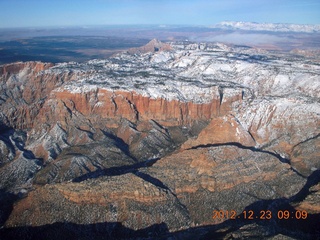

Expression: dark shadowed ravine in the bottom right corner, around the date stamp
xmin=170 ymin=170 xmax=320 ymax=240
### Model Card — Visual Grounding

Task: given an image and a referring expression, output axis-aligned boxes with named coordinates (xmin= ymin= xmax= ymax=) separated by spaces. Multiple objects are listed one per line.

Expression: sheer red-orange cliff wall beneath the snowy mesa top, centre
xmin=39 ymin=89 xmax=241 ymax=128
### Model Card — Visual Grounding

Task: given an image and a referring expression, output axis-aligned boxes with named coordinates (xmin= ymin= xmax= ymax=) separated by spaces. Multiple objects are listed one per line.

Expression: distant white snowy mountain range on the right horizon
xmin=213 ymin=22 xmax=320 ymax=33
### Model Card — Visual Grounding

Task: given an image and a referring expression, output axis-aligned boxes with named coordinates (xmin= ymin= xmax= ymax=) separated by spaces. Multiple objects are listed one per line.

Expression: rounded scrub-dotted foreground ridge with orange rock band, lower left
xmin=6 ymin=174 xmax=189 ymax=232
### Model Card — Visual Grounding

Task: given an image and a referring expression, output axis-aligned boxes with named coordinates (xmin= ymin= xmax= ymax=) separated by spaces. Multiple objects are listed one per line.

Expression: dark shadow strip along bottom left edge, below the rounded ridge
xmin=0 ymin=222 xmax=169 ymax=240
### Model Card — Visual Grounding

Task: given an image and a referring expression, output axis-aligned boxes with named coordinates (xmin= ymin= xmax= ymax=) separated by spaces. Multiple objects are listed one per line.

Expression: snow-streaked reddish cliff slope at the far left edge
xmin=0 ymin=62 xmax=72 ymax=129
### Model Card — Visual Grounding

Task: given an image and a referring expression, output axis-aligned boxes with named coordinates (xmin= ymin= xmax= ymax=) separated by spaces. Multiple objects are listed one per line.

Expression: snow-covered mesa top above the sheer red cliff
xmin=45 ymin=42 xmax=320 ymax=103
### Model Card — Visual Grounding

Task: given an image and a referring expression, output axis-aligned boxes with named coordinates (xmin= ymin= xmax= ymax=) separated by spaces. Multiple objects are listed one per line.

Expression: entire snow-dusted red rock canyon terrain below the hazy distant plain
xmin=0 ymin=41 xmax=320 ymax=239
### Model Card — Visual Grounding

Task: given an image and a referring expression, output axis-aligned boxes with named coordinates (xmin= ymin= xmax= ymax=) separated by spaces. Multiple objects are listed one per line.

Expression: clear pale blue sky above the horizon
xmin=0 ymin=0 xmax=320 ymax=28
